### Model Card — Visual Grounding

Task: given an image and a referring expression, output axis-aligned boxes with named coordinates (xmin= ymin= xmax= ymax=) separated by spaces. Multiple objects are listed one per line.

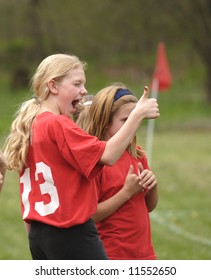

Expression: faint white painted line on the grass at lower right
xmin=150 ymin=212 xmax=211 ymax=247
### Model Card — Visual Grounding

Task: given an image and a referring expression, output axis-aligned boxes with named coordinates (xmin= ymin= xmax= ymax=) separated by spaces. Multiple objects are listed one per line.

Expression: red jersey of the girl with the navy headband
xmin=96 ymin=151 xmax=156 ymax=260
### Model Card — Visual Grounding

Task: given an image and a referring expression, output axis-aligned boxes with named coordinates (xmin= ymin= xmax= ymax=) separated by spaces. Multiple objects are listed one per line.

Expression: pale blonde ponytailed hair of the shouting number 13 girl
xmin=4 ymin=54 xmax=86 ymax=172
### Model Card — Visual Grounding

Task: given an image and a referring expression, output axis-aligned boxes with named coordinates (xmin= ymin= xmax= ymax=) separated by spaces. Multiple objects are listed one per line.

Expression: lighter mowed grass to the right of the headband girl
xmin=139 ymin=131 xmax=211 ymax=260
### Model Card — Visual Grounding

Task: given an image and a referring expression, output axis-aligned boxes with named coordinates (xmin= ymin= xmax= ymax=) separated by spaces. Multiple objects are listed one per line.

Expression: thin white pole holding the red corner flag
xmin=146 ymin=78 xmax=159 ymax=167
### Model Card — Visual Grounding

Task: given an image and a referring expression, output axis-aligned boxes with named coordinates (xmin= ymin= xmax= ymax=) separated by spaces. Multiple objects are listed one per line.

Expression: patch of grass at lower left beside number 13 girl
xmin=0 ymin=171 xmax=30 ymax=260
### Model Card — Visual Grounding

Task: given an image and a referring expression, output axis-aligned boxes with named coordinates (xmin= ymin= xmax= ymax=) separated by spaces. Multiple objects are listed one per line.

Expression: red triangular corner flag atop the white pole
xmin=153 ymin=42 xmax=172 ymax=91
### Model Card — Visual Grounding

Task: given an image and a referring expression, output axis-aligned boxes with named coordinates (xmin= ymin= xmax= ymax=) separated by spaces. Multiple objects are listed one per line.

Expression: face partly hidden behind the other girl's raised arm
xmin=106 ymin=102 xmax=136 ymax=140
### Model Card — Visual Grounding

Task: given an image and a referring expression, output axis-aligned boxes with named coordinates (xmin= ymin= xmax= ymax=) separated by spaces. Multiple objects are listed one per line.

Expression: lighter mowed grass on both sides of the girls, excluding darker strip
xmin=0 ymin=128 xmax=211 ymax=260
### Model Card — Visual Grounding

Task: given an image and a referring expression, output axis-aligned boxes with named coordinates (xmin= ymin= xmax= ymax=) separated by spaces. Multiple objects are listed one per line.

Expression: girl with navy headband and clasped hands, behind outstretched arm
xmin=87 ymin=84 xmax=158 ymax=259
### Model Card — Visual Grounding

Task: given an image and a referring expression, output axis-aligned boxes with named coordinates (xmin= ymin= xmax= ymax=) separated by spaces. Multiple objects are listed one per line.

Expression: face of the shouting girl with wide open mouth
xmin=51 ymin=68 xmax=87 ymax=116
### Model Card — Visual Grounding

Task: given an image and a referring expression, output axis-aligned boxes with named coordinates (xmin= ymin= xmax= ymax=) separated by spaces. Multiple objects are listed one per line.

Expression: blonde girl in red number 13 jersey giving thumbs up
xmin=4 ymin=54 xmax=159 ymax=260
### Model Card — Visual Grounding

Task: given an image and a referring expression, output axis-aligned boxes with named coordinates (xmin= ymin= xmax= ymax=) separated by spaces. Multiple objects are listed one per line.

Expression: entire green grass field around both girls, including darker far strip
xmin=0 ymin=67 xmax=211 ymax=260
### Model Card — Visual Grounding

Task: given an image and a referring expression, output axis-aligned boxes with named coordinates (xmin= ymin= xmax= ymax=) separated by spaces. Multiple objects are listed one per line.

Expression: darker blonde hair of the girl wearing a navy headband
xmin=86 ymin=83 xmax=145 ymax=158
